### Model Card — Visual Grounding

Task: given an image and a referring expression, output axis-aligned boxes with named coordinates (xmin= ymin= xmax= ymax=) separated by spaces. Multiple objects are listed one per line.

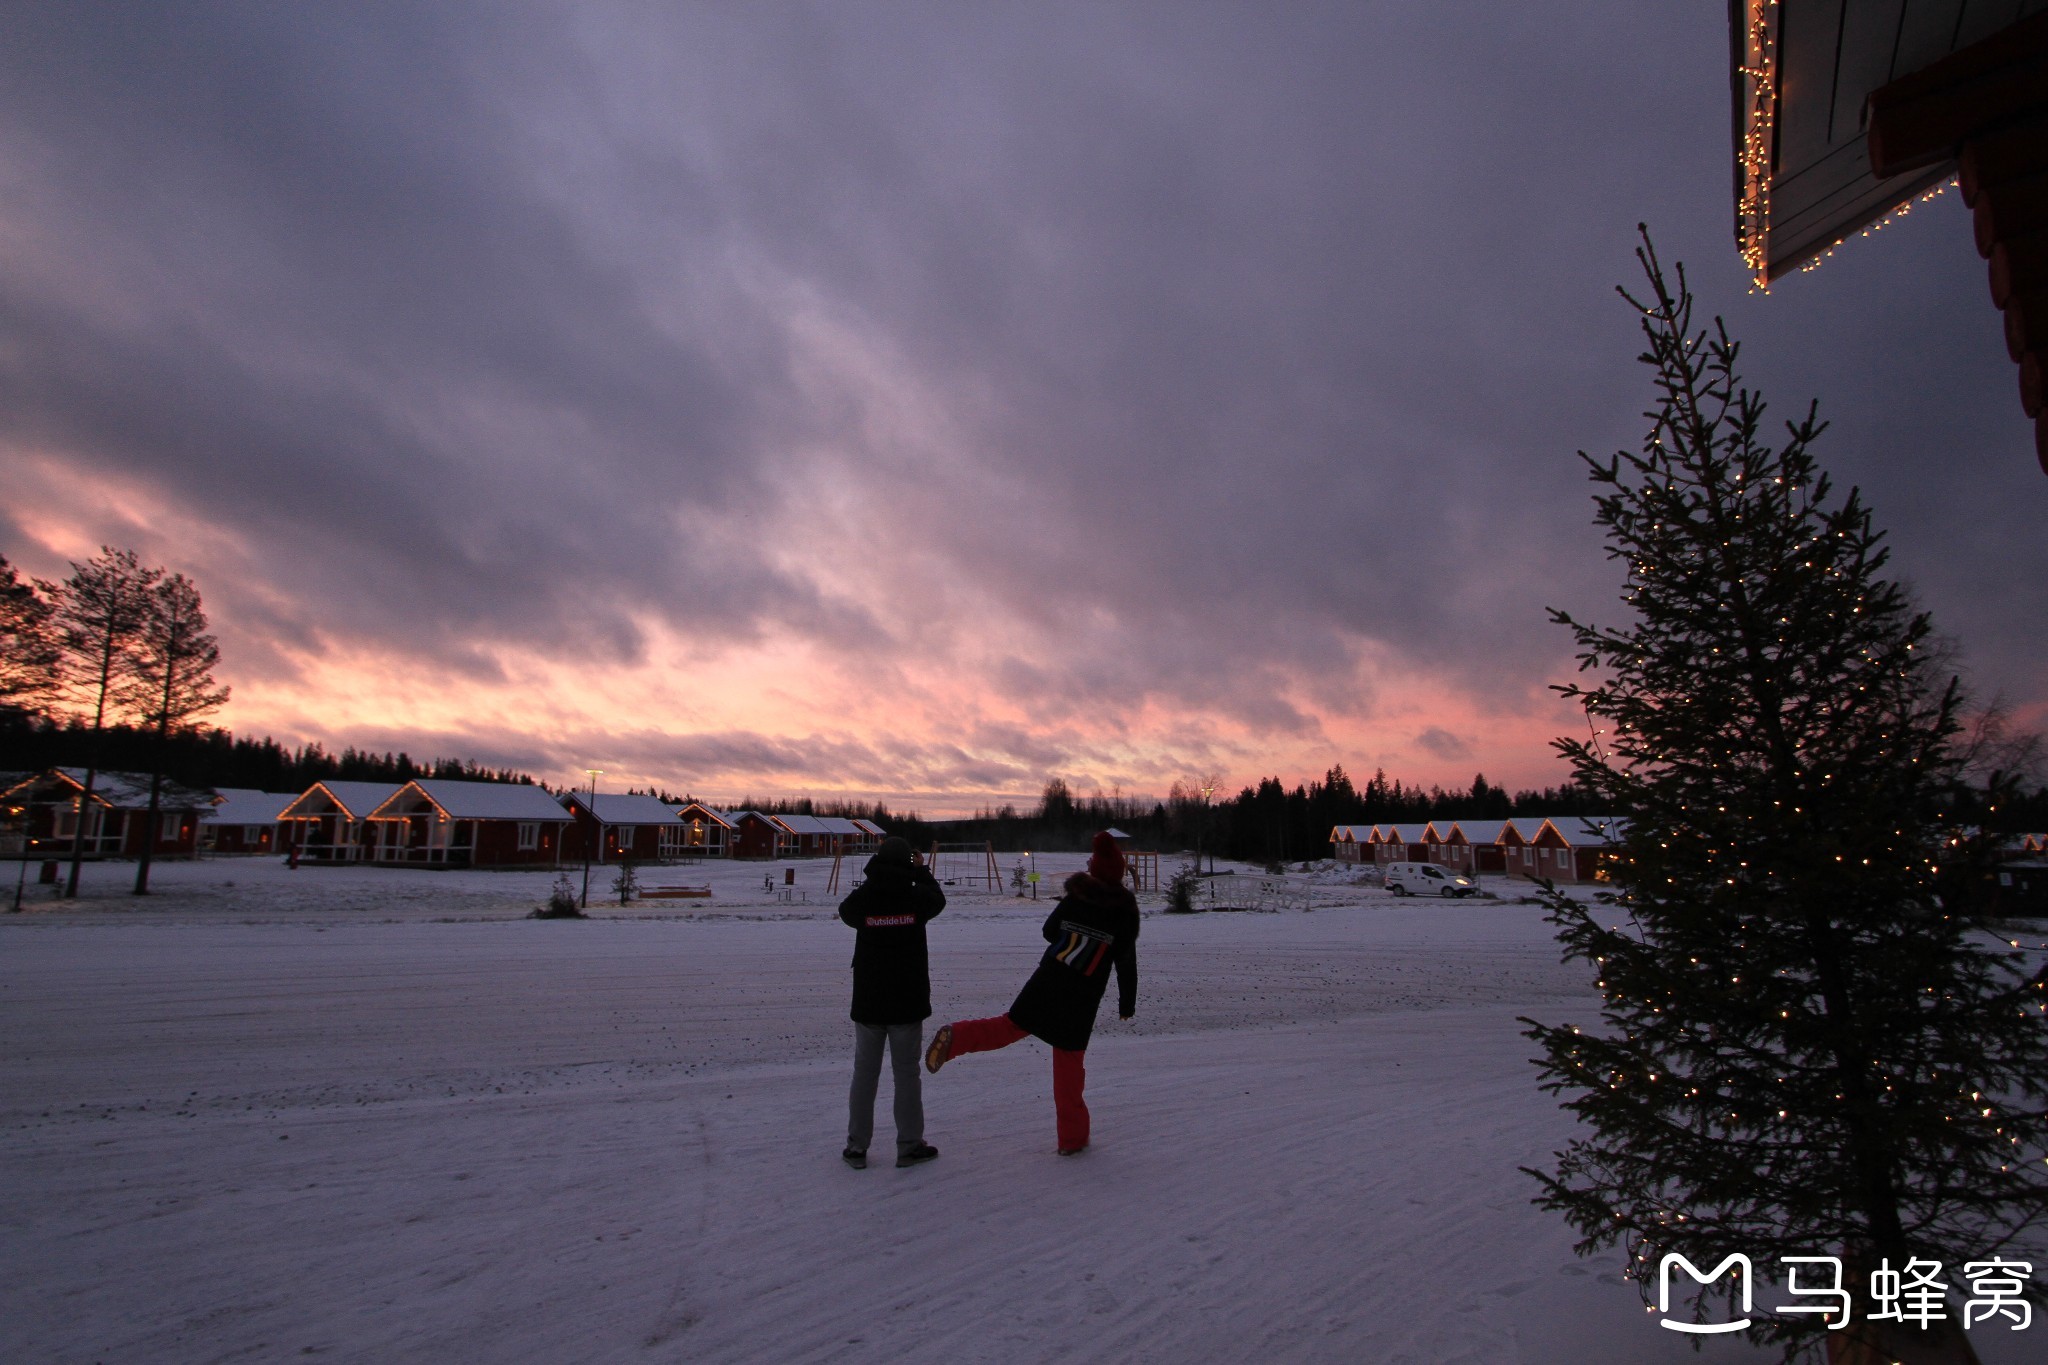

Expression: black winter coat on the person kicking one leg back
xmin=1010 ymin=872 xmax=1139 ymax=1052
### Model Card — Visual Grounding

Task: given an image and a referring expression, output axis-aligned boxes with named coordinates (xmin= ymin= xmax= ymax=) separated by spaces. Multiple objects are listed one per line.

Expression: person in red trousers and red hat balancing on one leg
xmin=924 ymin=831 xmax=1139 ymax=1156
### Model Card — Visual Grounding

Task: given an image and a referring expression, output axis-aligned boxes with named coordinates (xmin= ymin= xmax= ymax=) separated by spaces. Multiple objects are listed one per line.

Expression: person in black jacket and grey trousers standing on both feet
xmin=840 ymin=835 xmax=946 ymax=1171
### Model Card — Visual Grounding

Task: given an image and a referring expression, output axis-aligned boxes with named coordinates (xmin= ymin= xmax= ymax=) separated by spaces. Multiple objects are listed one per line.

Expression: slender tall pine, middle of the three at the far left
xmin=49 ymin=544 xmax=164 ymax=896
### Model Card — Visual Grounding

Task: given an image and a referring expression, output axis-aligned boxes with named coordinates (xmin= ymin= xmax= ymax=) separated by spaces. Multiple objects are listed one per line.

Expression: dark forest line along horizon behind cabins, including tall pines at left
xmin=12 ymin=551 xmax=2048 ymax=879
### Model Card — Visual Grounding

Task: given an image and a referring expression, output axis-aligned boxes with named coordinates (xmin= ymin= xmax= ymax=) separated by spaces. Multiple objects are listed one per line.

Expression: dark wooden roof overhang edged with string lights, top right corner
xmin=1729 ymin=0 xmax=2048 ymax=471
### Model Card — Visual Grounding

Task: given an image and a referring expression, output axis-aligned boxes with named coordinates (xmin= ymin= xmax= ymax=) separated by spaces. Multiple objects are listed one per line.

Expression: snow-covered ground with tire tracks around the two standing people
xmin=0 ymin=855 xmax=2048 ymax=1365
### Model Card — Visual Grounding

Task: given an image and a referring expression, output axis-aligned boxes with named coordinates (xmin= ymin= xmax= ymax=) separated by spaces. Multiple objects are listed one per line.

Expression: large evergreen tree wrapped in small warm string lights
xmin=1524 ymin=235 xmax=2048 ymax=1359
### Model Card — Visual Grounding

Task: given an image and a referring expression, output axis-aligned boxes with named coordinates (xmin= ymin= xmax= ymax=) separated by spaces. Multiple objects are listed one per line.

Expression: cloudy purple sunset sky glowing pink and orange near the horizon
xmin=0 ymin=0 xmax=2048 ymax=814
